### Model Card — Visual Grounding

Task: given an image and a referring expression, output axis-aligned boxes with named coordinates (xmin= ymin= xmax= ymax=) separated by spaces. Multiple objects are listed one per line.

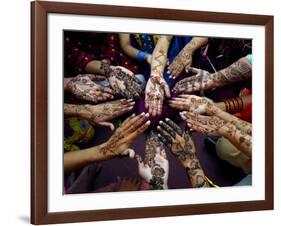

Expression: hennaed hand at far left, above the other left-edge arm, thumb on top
xmin=65 ymin=74 xmax=114 ymax=103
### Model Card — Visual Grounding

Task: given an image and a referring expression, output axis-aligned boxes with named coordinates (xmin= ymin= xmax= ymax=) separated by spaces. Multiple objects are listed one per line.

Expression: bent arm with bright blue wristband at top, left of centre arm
xmin=119 ymin=34 xmax=151 ymax=63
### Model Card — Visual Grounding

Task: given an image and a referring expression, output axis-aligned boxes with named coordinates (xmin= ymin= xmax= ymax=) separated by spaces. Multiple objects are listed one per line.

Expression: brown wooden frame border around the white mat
xmin=31 ymin=1 xmax=274 ymax=224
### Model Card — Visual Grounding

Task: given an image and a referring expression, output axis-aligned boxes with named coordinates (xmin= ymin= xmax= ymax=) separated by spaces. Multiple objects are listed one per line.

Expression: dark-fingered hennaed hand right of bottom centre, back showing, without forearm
xmin=157 ymin=118 xmax=196 ymax=167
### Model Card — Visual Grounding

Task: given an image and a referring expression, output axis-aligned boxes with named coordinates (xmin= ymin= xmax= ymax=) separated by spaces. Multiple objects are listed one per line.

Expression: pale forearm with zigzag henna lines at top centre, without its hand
xmin=151 ymin=36 xmax=172 ymax=77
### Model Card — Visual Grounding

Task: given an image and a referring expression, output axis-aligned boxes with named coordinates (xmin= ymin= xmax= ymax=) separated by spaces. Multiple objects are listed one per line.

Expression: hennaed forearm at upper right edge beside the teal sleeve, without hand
xmin=211 ymin=57 xmax=252 ymax=88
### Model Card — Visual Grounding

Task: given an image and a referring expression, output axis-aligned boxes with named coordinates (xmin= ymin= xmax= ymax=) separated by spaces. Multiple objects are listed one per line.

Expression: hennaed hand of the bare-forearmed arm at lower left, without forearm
xmin=100 ymin=113 xmax=150 ymax=159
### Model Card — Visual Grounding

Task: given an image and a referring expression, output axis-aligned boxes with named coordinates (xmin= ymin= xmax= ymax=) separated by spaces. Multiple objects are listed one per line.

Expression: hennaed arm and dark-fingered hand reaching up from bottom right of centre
xmin=157 ymin=118 xmax=209 ymax=188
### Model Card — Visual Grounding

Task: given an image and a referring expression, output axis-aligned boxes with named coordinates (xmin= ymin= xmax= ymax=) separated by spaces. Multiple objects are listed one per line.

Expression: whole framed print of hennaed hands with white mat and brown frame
xmin=31 ymin=1 xmax=273 ymax=224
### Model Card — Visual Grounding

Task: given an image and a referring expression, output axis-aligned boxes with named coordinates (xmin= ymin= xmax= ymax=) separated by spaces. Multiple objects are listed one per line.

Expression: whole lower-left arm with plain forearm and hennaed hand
xmin=64 ymin=114 xmax=150 ymax=171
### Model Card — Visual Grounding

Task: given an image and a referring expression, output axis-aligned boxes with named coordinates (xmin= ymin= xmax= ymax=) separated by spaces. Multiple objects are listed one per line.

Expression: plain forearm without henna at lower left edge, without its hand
xmin=63 ymin=144 xmax=106 ymax=172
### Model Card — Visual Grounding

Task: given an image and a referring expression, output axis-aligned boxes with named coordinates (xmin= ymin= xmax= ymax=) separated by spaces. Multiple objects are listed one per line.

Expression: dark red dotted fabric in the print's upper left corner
xmin=64 ymin=31 xmax=138 ymax=75
